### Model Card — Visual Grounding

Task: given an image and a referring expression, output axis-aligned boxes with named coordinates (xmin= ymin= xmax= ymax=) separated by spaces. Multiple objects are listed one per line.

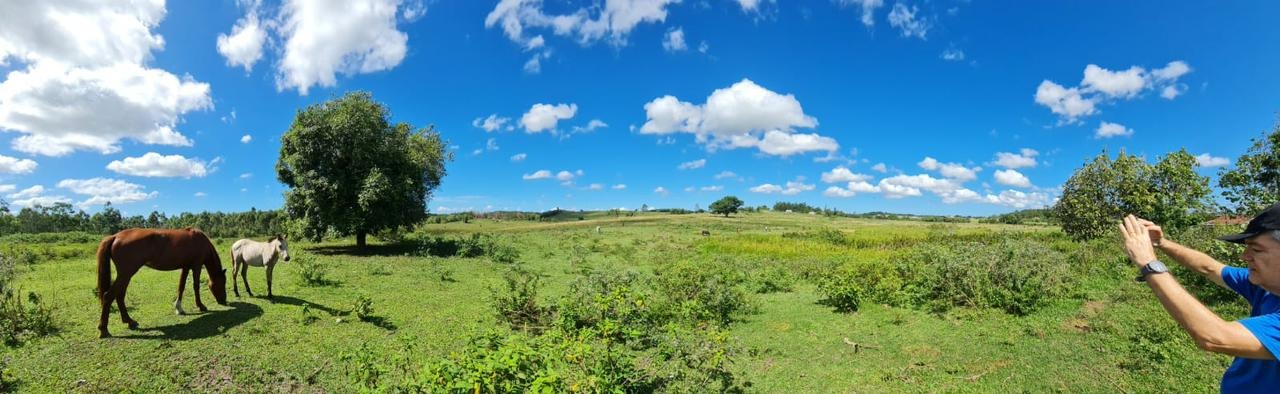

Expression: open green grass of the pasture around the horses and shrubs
xmin=3 ymin=212 xmax=1247 ymax=393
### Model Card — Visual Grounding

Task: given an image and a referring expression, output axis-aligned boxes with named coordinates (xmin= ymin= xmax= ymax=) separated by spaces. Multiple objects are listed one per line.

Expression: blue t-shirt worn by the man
xmin=1222 ymin=267 xmax=1280 ymax=393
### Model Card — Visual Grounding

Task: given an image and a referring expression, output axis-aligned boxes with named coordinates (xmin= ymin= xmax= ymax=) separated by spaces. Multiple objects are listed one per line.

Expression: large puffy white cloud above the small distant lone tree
xmin=640 ymin=79 xmax=840 ymax=156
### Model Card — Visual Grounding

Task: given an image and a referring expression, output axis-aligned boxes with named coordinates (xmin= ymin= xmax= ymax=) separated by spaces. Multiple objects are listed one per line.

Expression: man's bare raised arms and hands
xmin=1120 ymin=215 xmax=1275 ymax=359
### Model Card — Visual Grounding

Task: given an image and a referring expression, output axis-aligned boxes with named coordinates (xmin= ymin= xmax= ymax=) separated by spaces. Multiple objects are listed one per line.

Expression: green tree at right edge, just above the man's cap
xmin=1217 ymin=124 xmax=1280 ymax=216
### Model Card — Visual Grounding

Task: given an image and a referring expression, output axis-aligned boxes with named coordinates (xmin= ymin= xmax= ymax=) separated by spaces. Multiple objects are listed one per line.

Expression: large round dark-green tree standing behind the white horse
xmin=275 ymin=92 xmax=453 ymax=247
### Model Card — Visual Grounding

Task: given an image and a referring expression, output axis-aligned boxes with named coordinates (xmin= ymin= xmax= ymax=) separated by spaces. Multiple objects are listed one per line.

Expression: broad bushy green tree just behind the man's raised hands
xmin=1053 ymin=150 xmax=1213 ymax=239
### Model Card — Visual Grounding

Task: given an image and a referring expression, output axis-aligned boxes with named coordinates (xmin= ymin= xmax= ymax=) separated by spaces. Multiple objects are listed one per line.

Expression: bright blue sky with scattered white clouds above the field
xmin=0 ymin=0 xmax=1280 ymax=215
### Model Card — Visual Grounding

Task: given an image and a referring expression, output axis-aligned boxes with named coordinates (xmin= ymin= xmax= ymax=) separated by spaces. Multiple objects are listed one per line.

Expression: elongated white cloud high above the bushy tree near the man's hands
xmin=1036 ymin=60 xmax=1192 ymax=123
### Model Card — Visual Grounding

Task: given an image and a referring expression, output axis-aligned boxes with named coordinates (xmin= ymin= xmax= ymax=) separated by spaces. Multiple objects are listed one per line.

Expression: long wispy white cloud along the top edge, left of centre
xmin=484 ymin=0 xmax=678 ymax=46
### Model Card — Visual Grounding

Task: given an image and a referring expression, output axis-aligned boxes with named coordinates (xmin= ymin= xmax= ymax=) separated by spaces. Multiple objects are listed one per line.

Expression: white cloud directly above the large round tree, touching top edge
xmin=275 ymin=0 xmax=408 ymax=95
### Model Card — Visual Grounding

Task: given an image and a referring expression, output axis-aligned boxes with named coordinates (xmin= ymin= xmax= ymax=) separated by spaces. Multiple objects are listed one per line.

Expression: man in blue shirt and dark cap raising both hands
xmin=1120 ymin=203 xmax=1280 ymax=393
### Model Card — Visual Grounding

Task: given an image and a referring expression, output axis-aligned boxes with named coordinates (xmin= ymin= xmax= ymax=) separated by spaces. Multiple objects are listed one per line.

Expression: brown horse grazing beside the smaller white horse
xmin=97 ymin=228 xmax=227 ymax=338
